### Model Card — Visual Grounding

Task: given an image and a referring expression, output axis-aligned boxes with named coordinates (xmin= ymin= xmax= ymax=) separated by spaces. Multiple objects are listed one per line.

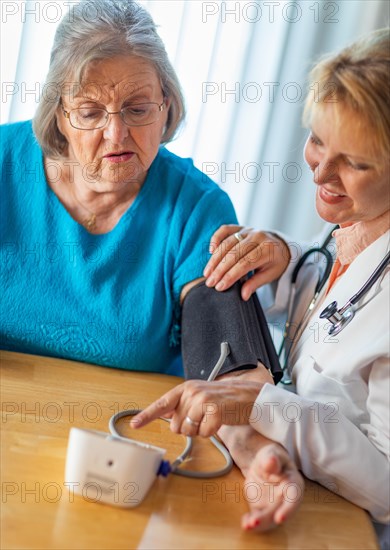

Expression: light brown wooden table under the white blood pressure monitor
xmin=0 ymin=352 xmax=378 ymax=550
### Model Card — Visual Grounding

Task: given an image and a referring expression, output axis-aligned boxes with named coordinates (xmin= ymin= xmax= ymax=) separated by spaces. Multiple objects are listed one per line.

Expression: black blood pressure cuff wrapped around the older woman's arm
xmin=181 ymin=282 xmax=283 ymax=384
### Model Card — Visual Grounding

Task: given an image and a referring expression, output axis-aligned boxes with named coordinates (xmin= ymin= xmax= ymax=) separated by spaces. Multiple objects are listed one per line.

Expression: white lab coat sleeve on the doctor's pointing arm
xmin=251 ymin=385 xmax=389 ymax=521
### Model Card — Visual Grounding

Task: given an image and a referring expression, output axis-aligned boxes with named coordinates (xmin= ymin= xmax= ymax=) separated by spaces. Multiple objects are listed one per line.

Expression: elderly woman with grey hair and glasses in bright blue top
xmin=0 ymin=0 xmax=236 ymax=372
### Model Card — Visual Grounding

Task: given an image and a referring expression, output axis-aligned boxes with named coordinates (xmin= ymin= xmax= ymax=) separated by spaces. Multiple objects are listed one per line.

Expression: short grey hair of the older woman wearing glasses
xmin=33 ymin=0 xmax=185 ymax=158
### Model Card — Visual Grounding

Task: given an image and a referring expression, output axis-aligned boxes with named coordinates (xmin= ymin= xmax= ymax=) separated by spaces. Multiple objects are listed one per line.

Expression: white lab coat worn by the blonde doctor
xmin=251 ymin=232 xmax=390 ymax=523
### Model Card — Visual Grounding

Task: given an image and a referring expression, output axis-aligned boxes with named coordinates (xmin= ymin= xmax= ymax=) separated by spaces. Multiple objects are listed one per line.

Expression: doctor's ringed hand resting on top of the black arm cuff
xmin=203 ymin=225 xmax=290 ymax=300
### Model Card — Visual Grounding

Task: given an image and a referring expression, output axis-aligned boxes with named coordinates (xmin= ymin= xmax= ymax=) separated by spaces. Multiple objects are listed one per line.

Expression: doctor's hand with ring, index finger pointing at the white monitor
xmin=130 ymin=377 xmax=264 ymax=437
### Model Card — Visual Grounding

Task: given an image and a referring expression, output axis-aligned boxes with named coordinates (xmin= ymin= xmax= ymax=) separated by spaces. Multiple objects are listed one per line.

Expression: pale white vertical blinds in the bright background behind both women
xmin=0 ymin=0 xmax=389 ymax=238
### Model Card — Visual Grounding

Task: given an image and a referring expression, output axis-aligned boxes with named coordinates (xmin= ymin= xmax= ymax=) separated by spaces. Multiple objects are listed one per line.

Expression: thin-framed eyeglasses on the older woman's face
xmin=62 ymin=102 xmax=165 ymax=130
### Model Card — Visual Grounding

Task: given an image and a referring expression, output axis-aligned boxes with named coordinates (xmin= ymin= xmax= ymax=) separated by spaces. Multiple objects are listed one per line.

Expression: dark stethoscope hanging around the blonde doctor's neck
xmin=278 ymin=226 xmax=390 ymax=384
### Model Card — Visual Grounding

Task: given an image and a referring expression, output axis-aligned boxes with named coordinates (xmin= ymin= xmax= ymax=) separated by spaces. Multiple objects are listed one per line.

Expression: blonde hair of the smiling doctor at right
xmin=303 ymin=28 xmax=390 ymax=159
